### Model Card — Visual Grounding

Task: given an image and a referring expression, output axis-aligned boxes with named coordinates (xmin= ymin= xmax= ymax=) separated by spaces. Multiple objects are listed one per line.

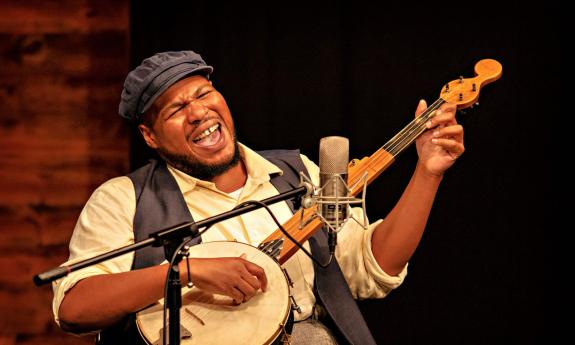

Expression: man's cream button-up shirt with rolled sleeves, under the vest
xmin=52 ymin=145 xmax=407 ymax=323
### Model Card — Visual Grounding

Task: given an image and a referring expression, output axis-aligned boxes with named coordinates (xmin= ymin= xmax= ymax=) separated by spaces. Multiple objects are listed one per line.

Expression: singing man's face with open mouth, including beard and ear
xmin=139 ymin=75 xmax=239 ymax=180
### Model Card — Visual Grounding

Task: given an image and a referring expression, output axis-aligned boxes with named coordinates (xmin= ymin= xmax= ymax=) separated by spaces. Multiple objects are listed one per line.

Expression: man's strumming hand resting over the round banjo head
xmin=186 ymin=255 xmax=267 ymax=304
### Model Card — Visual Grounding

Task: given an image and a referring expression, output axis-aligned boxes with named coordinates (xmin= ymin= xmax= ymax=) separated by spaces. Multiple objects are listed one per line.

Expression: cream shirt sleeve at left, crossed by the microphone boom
xmin=52 ymin=176 xmax=136 ymax=324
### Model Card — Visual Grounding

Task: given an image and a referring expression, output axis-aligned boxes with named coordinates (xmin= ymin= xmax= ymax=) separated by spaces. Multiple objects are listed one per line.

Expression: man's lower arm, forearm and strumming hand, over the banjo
xmin=58 ymin=256 xmax=267 ymax=333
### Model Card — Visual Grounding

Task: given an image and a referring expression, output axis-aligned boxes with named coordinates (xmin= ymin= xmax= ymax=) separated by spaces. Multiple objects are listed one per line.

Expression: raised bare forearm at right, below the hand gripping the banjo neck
xmin=372 ymin=164 xmax=442 ymax=275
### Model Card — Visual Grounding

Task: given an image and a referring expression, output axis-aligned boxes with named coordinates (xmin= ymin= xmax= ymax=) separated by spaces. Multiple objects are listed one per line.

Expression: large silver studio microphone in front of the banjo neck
xmin=319 ymin=136 xmax=349 ymax=254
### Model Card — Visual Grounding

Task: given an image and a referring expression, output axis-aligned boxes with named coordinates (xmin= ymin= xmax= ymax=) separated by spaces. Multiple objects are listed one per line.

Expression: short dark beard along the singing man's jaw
xmin=158 ymin=135 xmax=240 ymax=181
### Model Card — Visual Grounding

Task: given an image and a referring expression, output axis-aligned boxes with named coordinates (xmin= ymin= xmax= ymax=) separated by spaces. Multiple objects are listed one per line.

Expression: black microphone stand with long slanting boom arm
xmin=33 ymin=185 xmax=311 ymax=345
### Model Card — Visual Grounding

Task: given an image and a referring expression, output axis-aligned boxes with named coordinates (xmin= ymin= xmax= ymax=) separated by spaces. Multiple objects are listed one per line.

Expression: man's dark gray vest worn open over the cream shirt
xmin=128 ymin=150 xmax=375 ymax=345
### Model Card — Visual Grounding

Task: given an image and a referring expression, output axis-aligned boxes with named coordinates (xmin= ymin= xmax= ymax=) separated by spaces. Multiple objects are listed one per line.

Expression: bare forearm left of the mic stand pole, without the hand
xmin=58 ymin=265 xmax=184 ymax=333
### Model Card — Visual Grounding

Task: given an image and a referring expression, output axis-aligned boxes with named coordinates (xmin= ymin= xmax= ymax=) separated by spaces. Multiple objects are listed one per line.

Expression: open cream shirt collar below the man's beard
xmin=168 ymin=143 xmax=283 ymax=194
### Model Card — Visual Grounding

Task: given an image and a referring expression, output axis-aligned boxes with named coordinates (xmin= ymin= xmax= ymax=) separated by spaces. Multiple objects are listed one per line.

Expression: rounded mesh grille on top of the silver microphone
xmin=319 ymin=136 xmax=349 ymax=174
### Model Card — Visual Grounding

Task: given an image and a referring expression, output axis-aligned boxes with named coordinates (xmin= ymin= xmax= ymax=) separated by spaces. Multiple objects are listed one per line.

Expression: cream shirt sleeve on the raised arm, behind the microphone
xmin=302 ymin=155 xmax=407 ymax=299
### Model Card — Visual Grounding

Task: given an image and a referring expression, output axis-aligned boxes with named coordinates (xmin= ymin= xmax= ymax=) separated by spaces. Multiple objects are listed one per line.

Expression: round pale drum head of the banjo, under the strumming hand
xmin=136 ymin=241 xmax=291 ymax=345
